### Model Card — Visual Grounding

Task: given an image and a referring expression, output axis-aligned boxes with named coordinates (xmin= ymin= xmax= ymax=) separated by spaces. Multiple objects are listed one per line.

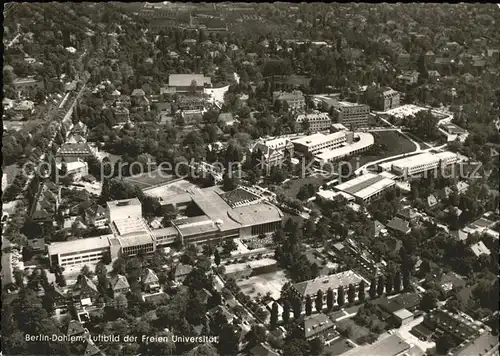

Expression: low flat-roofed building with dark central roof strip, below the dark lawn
xmin=333 ymin=173 xmax=396 ymax=203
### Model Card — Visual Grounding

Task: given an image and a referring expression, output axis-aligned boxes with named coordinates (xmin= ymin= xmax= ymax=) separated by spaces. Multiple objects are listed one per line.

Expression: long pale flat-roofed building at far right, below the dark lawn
xmin=391 ymin=151 xmax=458 ymax=176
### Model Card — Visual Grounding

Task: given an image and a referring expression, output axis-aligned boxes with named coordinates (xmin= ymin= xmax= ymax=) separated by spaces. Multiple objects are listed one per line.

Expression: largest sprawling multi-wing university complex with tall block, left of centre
xmin=48 ymin=189 xmax=283 ymax=267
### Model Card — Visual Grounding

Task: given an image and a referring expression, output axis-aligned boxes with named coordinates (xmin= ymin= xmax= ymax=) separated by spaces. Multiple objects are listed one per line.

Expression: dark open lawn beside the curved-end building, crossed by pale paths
xmin=349 ymin=131 xmax=416 ymax=169
